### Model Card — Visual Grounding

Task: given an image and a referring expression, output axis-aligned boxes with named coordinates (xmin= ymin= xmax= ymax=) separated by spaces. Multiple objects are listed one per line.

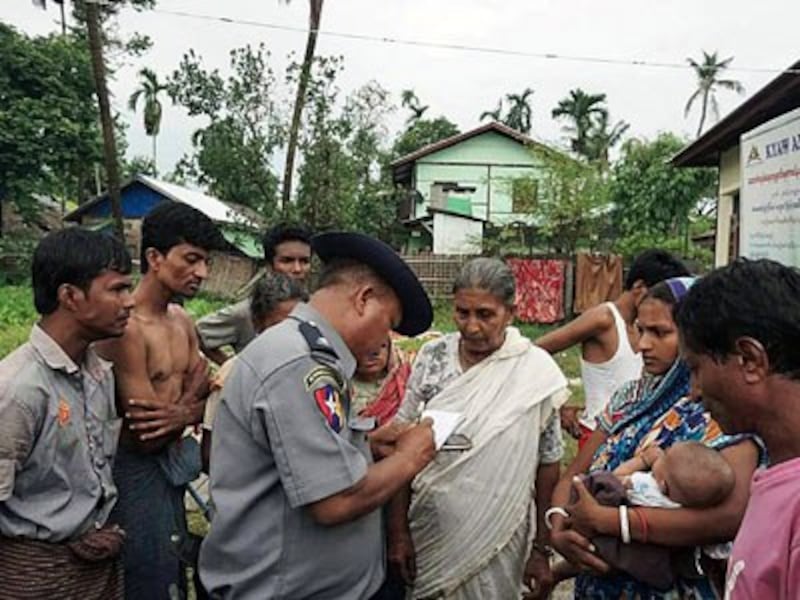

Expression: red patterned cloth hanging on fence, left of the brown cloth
xmin=506 ymin=258 xmax=565 ymax=323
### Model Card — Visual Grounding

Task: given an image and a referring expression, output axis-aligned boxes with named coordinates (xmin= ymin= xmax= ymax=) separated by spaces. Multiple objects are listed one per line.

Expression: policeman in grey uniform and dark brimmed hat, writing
xmin=200 ymin=233 xmax=434 ymax=600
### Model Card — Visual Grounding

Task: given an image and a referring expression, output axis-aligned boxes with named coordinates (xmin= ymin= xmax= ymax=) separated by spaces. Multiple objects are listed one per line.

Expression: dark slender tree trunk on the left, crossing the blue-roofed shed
xmin=86 ymin=0 xmax=125 ymax=242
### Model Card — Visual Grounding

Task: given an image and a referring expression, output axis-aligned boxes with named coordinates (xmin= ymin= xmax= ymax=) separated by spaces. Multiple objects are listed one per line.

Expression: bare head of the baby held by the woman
xmin=652 ymin=442 xmax=736 ymax=508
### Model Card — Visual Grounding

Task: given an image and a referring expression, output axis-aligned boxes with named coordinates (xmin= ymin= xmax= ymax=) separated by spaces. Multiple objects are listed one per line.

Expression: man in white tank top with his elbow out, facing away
xmin=536 ymin=249 xmax=689 ymax=447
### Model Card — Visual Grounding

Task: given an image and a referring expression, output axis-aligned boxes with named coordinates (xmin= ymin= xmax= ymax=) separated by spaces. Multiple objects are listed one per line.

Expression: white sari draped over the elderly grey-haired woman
xmin=399 ymin=327 xmax=567 ymax=599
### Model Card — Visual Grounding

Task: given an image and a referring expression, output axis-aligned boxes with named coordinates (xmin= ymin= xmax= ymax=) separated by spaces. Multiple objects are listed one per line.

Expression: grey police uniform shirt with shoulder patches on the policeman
xmin=200 ymin=304 xmax=384 ymax=600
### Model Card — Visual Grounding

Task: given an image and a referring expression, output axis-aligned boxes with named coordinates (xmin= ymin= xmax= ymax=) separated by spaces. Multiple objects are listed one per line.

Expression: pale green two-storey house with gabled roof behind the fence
xmin=391 ymin=122 xmax=555 ymax=253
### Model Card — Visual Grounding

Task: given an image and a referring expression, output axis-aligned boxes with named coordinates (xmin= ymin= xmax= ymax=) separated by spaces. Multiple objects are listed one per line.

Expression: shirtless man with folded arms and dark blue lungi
xmin=100 ymin=202 xmax=225 ymax=600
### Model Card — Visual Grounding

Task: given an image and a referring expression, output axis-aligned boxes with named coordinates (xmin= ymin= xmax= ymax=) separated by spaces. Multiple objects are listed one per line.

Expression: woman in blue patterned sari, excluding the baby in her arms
xmin=544 ymin=278 xmax=759 ymax=600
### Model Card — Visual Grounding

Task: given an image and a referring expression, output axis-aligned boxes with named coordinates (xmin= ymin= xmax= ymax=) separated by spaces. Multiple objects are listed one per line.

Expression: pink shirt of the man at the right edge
xmin=725 ymin=458 xmax=800 ymax=600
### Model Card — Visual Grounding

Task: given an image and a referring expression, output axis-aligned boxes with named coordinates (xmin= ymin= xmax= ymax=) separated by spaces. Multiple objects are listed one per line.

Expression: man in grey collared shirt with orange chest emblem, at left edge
xmin=0 ymin=228 xmax=133 ymax=600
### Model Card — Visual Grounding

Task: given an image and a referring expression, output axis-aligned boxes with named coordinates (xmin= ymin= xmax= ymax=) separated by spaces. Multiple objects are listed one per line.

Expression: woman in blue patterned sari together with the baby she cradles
xmin=537 ymin=278 xmax=759 ymax=600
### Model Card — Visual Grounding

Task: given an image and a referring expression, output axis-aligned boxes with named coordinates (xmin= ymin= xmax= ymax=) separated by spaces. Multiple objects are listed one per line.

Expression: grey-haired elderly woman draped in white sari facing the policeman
xmin=389 ymin=258 xmax=567 ymax=599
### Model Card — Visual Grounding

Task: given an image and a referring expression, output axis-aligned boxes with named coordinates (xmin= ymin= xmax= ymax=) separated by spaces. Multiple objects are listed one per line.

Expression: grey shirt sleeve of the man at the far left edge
xmin=0 ymin=394 xmax=37 ymax=502
